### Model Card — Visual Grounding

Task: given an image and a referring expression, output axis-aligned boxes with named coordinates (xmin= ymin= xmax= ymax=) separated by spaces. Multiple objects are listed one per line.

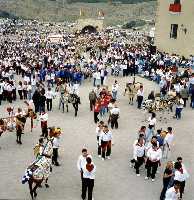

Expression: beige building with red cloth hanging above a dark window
xmin=155 ymin=0 xmax=194 ymax=57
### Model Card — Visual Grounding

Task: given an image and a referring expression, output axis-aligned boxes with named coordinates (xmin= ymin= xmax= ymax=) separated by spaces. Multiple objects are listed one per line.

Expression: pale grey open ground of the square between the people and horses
xmin=0 ymin=77 xmax=194 ymax=200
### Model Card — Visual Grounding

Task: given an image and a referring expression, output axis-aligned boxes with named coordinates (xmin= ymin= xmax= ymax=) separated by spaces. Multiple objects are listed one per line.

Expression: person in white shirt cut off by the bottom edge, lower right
xmin=165 ymin=181 xmax=180 ymax=200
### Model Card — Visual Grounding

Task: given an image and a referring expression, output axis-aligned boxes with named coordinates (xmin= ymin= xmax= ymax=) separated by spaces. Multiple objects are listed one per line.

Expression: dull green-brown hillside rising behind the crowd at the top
xmin=0 ymin=0 xmax=156 ymax=25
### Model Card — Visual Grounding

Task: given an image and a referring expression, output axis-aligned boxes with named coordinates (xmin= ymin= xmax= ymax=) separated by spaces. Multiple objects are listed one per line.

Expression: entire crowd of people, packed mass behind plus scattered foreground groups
xmin=0 ymin=18 xmax=194 ymax=200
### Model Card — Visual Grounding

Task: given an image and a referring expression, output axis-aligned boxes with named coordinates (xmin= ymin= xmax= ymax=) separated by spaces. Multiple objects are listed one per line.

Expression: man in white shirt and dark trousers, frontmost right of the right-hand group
xmin=145 ymin=142 xmax=162 ymax=181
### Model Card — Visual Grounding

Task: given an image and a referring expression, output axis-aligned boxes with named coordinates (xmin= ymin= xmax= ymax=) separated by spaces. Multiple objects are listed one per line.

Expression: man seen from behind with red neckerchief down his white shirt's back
xmin=81 ymin=157 xmax=96 ymax=200
